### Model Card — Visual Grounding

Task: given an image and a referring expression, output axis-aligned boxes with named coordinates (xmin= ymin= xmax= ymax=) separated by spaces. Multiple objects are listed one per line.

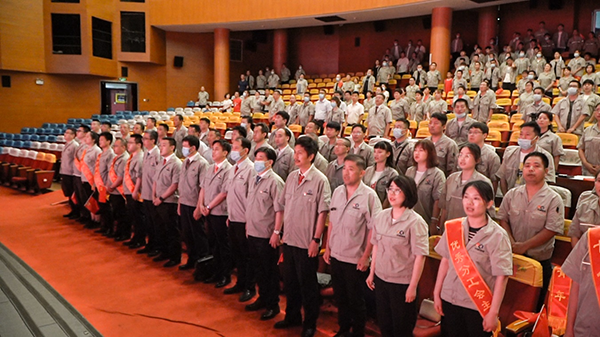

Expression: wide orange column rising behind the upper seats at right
xmin=430 ymin=7 xmax=452 ymax=76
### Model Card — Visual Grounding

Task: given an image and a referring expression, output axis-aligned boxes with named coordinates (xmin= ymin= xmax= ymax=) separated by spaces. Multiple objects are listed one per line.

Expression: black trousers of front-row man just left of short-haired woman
xmin=331 ymin=258 xmax=369 ymax=336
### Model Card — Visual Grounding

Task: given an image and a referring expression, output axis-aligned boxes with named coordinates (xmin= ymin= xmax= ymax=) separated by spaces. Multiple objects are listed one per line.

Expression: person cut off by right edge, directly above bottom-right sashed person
xmin=568 ymin=173 xmax=600 ymax=247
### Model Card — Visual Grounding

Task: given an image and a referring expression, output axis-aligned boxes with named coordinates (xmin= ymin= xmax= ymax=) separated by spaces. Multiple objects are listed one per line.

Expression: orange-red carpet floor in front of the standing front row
xmin=0 ymin=187 xmax=346 ymax=337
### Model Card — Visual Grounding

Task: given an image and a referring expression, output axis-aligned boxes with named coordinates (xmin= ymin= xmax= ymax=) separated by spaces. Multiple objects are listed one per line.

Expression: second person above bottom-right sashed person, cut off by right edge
xmin=577 ymin=103 xmax=600 ymax=176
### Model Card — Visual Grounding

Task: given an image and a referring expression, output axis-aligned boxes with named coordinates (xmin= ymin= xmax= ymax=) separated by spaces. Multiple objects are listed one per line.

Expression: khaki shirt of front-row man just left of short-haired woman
xmin=328 ymin=183 xmax=381 ymax=264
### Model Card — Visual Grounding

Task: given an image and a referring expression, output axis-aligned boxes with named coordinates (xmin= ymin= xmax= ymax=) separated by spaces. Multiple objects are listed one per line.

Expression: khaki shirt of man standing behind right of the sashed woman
xmin=498 ymin=185 xmax=565 ymax=261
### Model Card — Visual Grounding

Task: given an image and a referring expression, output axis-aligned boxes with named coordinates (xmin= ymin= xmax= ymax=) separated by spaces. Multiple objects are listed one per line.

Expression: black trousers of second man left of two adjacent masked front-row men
xmin=179 ymin=204 xmax=208 ymax=263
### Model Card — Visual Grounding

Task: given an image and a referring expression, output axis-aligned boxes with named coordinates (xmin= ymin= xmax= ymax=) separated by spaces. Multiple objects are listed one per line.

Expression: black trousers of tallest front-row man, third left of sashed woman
xmin=282 ymin=244 xmax=320 ymax=329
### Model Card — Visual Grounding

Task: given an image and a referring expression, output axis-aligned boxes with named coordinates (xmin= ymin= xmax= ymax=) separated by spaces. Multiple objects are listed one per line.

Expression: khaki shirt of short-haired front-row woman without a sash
xmin=371 ymin=208 xmax=429 ymax=284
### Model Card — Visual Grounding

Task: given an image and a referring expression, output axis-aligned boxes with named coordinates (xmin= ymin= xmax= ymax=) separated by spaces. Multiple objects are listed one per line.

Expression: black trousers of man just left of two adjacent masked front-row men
xmin=206 ymin=214 xmax=233 ymax=277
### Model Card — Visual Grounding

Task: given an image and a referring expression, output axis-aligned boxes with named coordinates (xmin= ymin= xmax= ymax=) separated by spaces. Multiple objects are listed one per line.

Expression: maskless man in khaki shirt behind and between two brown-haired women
xmin=426 ymin=113 xmax=458 ymax=177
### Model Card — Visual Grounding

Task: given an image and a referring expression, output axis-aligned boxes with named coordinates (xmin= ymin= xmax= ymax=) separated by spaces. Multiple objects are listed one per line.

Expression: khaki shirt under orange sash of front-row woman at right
xmin=435 ymin=217 xmax=513 ymax=311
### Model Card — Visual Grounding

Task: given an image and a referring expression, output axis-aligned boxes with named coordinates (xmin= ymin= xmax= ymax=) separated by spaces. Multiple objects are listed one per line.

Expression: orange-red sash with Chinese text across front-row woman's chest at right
xmin=446 ymin=218 xmax=492 ymax=317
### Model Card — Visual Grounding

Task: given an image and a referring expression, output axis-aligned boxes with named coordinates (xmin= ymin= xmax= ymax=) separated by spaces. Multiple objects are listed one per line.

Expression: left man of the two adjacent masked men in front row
xmin=223 ymin=137 xmax=256 ymax=302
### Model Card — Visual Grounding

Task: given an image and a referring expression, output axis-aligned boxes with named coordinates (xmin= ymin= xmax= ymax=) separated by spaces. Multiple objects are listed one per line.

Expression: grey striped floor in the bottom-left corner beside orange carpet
xmin=0 ymin=243 xmax=102 ymax=337
